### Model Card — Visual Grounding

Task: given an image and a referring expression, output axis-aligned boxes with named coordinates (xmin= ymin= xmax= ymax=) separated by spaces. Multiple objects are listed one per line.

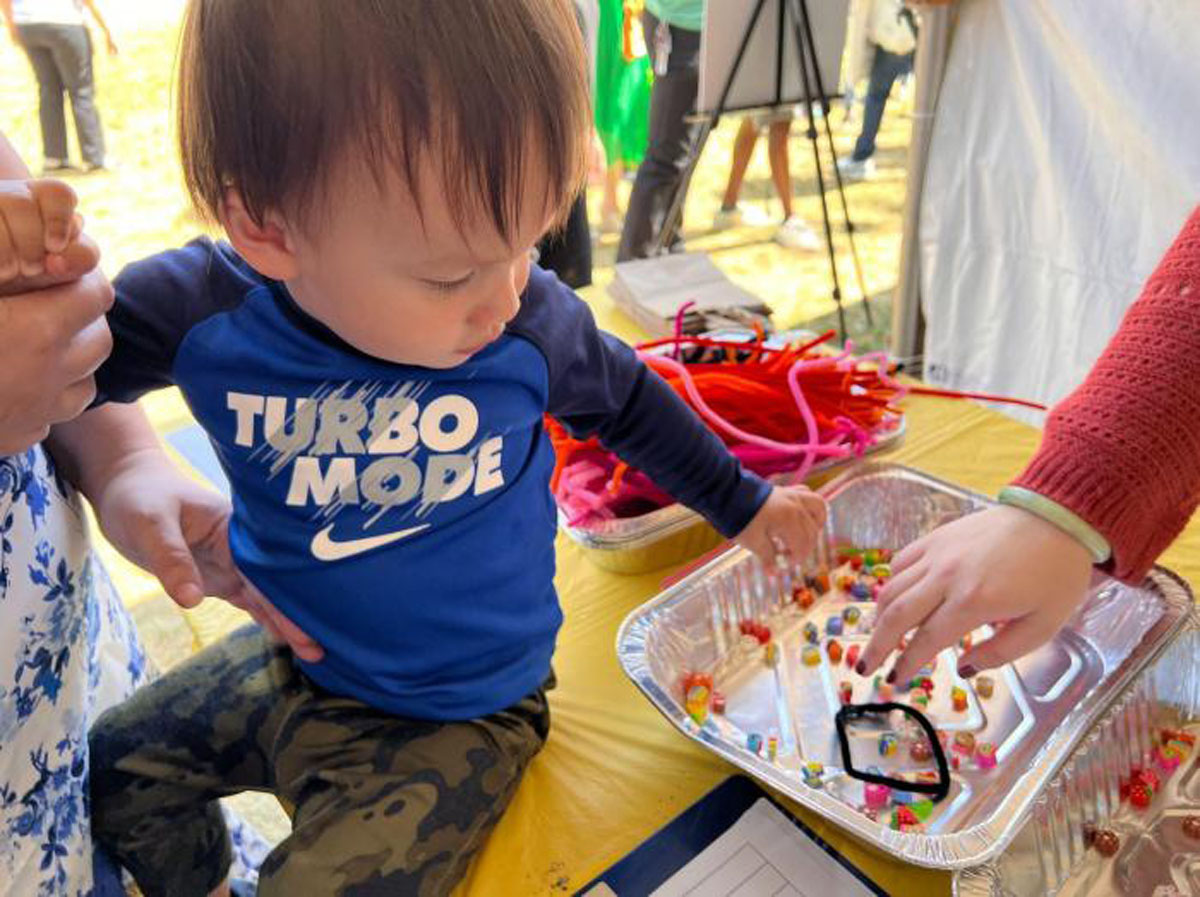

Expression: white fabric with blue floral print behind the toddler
xmin=0 ymin=447 xmax=266 ymax=897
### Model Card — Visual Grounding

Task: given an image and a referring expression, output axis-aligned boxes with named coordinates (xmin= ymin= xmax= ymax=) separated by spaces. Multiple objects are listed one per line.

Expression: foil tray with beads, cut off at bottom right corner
xmin=954 ymin=620 xmax=1200 ymax=897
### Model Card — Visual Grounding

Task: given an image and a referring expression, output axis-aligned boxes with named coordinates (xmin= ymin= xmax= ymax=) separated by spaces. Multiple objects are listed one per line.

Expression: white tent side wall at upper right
xmin=896 ymin=0 xmax=1200 ymax=422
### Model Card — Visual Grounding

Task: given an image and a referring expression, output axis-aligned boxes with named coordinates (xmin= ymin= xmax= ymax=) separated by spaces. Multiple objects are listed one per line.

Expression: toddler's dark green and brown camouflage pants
xmin=91 ymin=626 xmax=552 ymax=897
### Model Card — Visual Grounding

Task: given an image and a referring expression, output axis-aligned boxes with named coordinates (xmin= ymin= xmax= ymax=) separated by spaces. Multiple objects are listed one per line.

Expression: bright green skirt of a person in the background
xmin=594 ymin=0 xmax=654 ymax=168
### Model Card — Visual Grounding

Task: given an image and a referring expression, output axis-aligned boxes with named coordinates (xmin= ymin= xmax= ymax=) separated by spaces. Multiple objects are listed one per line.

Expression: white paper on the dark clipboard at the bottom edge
xmin=653 ymin=799 xmax=874 ymax=897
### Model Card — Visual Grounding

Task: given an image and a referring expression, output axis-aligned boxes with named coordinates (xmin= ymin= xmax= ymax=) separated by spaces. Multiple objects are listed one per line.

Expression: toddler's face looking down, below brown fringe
xmin=288 ymin=154 xmax=552 ymax=368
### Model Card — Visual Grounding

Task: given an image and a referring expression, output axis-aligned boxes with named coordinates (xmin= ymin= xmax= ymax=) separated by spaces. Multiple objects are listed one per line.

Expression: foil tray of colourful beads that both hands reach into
xmin=617 ymin=464 xmax=1200 ymax=863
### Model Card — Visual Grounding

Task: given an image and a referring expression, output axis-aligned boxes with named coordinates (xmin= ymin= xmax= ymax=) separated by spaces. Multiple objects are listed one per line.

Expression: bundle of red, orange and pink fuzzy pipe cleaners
xmin=546 ymin=309 xmax=1042 ymax=526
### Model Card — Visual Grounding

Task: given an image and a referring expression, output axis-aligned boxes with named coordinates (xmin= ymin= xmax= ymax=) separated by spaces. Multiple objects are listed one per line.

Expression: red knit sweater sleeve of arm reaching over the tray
xmin=1015 ymin=207 xmax=1200 ymax=582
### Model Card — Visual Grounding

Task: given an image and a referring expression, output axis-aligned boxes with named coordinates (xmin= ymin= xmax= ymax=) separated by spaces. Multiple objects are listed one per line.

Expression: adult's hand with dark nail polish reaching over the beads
xmin=858 ymin=506 xmax=1092 ymax=682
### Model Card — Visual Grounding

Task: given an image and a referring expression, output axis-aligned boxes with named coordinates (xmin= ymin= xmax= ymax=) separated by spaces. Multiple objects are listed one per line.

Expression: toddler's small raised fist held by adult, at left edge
xmin=0 ymin=180 xmax=83 ymax=283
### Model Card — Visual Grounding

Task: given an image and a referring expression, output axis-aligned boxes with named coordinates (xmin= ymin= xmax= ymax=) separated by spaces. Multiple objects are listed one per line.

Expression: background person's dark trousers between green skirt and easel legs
xmin=617 ymin=12 xmax=700 ymax=261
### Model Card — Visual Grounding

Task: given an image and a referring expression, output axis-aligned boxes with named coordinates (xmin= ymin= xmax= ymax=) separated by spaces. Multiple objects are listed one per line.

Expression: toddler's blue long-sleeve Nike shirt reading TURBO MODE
xmin=97 ymin=240 xmax=769 ymax=720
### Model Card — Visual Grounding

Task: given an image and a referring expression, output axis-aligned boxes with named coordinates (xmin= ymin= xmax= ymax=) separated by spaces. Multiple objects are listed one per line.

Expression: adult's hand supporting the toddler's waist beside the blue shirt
xmin=94 ymin=451 xmax=324 ymax=662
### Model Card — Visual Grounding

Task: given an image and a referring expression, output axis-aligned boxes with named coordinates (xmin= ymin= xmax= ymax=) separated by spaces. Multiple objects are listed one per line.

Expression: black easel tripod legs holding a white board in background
xmin=654 ymin=0 xmax=875 ymax=341
